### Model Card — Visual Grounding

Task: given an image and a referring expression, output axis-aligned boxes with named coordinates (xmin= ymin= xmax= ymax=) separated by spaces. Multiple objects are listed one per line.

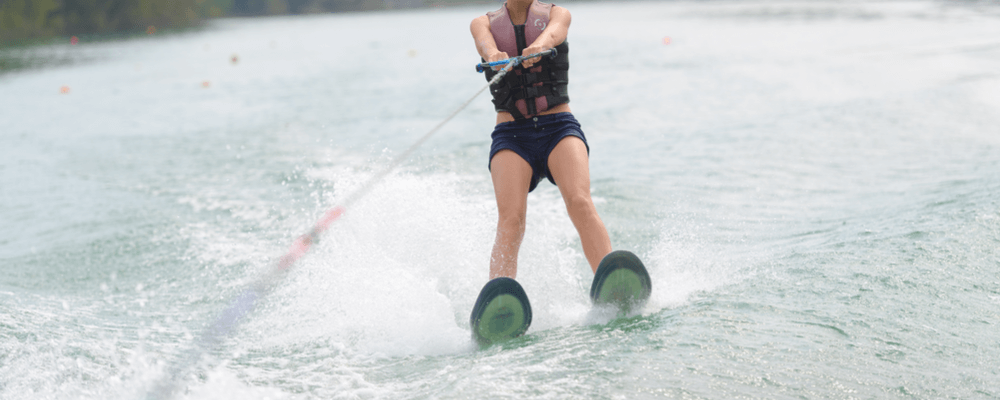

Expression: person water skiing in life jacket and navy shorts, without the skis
xmin=471 ymin=0 xmax=611 ymax=279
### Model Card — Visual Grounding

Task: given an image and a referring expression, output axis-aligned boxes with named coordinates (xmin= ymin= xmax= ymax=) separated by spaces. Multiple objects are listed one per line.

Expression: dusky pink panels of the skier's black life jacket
xmin=486 ymin=0 xmax=553 ymax=118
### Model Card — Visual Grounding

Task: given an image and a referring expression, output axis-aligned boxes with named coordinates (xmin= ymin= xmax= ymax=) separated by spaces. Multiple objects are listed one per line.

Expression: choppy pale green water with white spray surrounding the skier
xmin=0 ymin=2 xmax=1000 ymax=399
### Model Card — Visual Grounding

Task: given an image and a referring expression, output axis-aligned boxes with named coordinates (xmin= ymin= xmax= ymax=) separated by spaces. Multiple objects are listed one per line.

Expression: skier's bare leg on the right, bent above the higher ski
xmin=549 ymin=136 xmax=611 ymax=273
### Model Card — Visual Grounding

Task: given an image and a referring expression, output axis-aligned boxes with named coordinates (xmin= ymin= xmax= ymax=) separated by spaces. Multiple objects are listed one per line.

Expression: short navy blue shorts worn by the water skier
xmin=490 ymin=112 xmax=590 ymax=192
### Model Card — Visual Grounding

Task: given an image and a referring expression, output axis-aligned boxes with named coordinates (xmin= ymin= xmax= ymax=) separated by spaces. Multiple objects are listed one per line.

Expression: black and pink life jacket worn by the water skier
xmin=484 ymin=0 xmax=569 ymax=119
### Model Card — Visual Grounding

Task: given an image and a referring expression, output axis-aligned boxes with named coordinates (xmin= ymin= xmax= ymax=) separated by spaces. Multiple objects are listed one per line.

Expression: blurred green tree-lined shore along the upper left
xmin=0 ymin=0 xmax=438 ymax=45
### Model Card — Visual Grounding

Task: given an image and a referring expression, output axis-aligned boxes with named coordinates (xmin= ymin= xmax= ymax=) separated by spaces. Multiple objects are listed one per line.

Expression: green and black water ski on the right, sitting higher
xmin=590 ymin=250 xmax=653 ymax=313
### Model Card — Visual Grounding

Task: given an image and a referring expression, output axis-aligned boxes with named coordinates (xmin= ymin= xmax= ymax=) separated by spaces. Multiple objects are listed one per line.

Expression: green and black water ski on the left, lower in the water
xmin=469 ymin=278 xmax=531 ymax=345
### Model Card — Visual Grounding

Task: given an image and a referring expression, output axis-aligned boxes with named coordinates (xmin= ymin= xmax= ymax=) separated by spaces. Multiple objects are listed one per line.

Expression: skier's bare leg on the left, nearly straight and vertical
xmin=490 ymin=150 xmax=532 ymax=279
